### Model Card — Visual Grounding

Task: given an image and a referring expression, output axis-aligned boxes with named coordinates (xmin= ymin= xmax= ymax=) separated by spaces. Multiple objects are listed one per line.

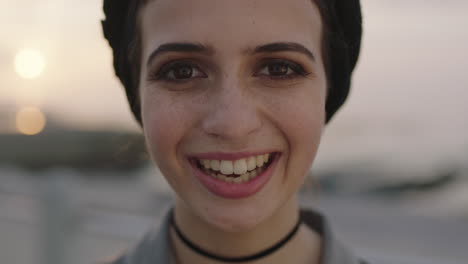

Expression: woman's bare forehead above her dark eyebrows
xmin=140 ymin=0 xmax=322 ymax=55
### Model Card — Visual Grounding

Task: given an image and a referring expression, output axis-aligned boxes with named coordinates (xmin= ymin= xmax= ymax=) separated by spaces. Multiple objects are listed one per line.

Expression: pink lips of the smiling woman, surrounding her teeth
xmin=189 ymin=152 xmax=281 ymax=199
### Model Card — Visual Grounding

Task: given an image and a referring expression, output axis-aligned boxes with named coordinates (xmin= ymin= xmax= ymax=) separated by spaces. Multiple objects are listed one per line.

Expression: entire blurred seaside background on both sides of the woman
xmin=0 ymin=0 xmax=468 ymax=264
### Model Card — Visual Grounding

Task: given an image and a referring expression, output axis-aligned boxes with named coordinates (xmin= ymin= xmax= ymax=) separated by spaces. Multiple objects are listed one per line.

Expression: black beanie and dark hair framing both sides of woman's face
xmin=102 ymin=0 xmax=362 ymax=125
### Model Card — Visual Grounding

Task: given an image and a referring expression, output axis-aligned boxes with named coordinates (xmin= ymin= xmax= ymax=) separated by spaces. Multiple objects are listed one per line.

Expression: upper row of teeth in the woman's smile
xmin=201 ymin=154 xmax=270 ymax=175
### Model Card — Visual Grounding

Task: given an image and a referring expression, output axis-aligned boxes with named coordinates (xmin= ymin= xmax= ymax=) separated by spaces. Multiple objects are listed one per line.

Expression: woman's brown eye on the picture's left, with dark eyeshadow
xmin=149 ymin=61 xmax=207 ymax=82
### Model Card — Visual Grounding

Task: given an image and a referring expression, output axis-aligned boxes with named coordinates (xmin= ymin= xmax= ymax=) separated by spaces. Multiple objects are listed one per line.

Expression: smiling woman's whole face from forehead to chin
xmin=139 ymin=0 xmax=326 ymax=230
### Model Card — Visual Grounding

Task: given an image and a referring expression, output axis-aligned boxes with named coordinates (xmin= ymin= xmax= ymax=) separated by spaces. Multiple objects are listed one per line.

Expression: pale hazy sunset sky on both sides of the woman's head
xmin=0 ymin=0 xmax=468 ymax=165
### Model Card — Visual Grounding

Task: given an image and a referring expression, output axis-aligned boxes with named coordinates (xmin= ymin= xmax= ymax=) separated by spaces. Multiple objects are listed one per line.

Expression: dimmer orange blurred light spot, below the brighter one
xmin=16 ymin=107 xmax=46 ymax=135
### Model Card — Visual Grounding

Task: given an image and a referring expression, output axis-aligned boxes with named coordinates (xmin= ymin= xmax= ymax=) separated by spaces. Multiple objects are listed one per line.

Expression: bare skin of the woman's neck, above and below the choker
xmin=171 ymin=198 xmax=320 ymax=264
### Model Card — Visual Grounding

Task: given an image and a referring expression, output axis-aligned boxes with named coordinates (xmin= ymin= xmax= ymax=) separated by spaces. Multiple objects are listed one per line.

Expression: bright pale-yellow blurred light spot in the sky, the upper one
xmin=15 ymin=49 xmax=45 ymax=79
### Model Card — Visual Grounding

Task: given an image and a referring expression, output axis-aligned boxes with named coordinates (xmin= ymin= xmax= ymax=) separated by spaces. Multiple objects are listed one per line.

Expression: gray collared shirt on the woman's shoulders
xmin=110 ymin=210 xmax=365 ymax=264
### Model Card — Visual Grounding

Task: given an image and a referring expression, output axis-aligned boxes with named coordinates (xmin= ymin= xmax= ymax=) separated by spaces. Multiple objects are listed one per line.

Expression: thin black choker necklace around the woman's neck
xmin=170 ymin=211 xmax=302 ymax=262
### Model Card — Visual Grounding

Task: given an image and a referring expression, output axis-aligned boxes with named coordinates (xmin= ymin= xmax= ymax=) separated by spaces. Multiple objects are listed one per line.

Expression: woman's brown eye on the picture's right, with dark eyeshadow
xmin=254 ymin=59 xmax=310 ymax=80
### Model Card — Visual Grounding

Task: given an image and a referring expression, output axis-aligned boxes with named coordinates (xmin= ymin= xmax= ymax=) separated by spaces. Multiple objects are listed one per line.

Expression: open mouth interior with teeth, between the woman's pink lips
xmin=195 ymin=153 xmax=277 ymax=183
